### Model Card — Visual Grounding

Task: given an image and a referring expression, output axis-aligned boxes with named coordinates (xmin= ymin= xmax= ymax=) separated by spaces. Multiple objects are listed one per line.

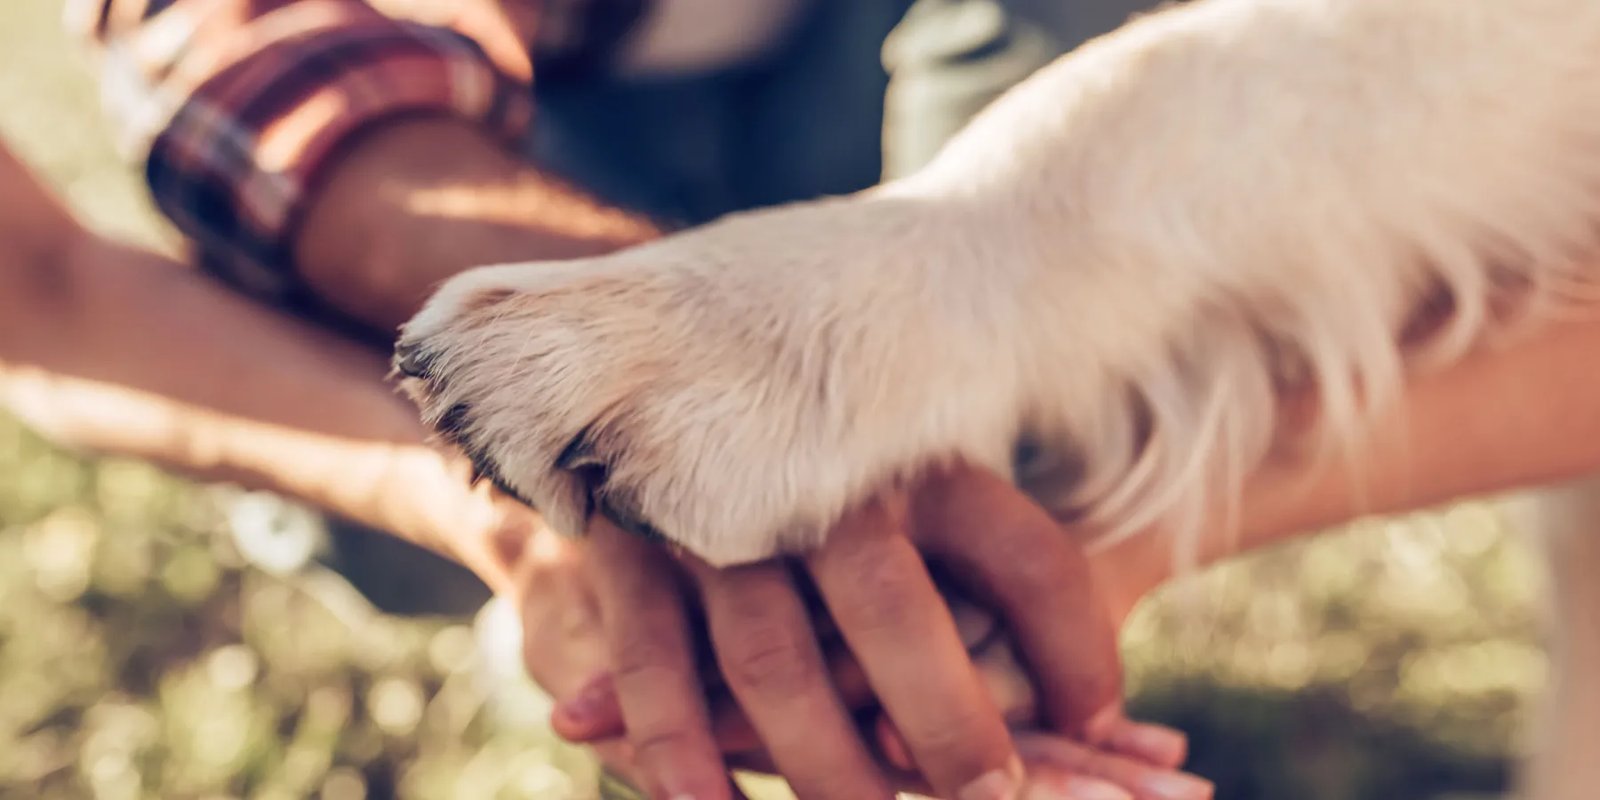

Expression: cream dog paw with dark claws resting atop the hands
xmin=395 ymin=195 xmax=1021 ymax=565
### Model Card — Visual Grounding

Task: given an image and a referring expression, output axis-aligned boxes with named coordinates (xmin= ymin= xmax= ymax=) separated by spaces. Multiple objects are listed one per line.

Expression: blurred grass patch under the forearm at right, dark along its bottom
xmin=1123 ymin=504 xmax=1546 ymax=800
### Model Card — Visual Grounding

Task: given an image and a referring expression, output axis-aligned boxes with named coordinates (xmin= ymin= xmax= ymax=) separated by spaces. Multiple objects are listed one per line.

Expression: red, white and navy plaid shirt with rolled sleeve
xmin=67 ymin=0 xmax=642 ymax=302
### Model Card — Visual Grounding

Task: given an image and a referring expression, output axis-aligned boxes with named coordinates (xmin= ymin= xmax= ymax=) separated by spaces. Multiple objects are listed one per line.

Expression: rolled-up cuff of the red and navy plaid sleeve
xmin=146 ymin=3 xmax=530 ymax=301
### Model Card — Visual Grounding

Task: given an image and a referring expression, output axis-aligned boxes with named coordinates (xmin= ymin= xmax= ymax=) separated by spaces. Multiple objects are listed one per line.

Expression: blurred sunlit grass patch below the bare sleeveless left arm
xmin=0 ymin=422 xmax=592 ymax=800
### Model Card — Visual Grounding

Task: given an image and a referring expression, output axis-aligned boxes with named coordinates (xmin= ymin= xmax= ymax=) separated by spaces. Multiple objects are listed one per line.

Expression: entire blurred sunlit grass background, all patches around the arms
xmin=0 ymin=0 xmax=1544 ymax=800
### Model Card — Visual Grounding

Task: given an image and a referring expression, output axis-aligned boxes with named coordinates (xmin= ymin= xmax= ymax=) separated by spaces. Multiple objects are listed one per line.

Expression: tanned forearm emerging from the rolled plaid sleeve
xmin=294 ymin=118 xmax=656 ymax=331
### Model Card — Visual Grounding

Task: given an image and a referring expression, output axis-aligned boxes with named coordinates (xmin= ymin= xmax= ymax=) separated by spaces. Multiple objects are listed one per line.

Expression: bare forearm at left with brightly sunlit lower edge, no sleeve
xmin=0 ymin=237 xmax=518 ymax=585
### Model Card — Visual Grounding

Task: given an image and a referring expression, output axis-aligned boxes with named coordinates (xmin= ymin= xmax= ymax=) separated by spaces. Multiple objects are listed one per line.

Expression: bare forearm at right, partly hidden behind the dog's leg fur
xmin=1096 ymin=312 xmax=1600 ymax=603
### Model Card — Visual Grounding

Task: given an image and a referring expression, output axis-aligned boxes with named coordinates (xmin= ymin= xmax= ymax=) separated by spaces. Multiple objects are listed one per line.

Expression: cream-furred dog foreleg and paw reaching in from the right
xmin=405 ymin=0 xmax=1600 ymax=798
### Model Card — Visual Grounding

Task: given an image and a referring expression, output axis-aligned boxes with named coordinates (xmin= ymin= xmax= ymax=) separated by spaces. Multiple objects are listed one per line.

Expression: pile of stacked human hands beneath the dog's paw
xmin=555 ymin=470 xmax=1210 ymax=800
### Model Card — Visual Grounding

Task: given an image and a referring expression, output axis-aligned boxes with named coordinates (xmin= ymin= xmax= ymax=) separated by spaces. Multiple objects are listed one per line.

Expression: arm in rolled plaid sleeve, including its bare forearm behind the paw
xmin=72 ymin=0 xmax=650 ymax=334
